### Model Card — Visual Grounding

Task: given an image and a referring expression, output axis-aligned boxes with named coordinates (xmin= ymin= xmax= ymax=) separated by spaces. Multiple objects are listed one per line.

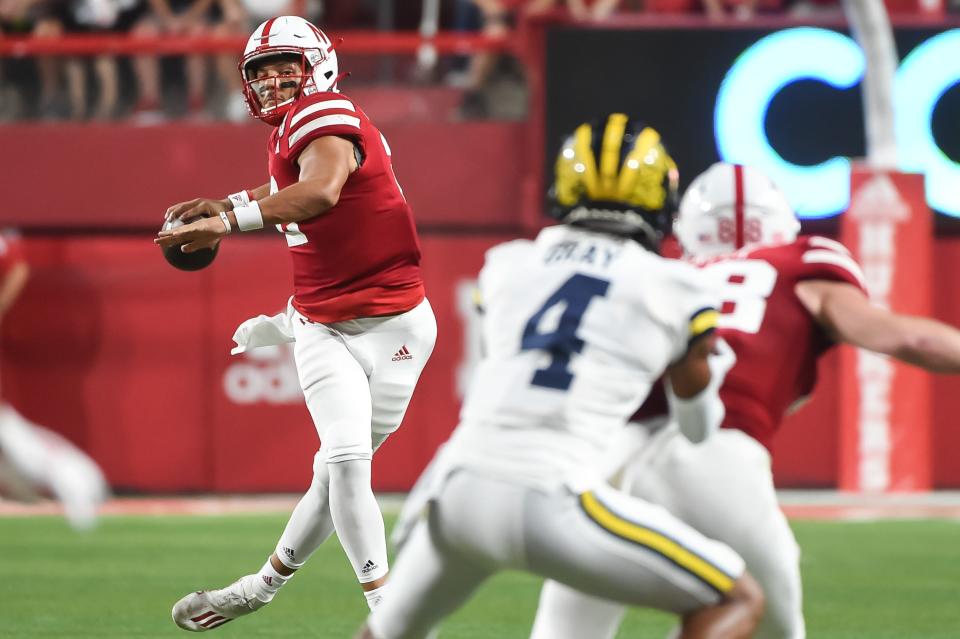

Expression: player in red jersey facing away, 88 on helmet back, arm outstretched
xmin=531 ymin=163 xmax=960 ymax=639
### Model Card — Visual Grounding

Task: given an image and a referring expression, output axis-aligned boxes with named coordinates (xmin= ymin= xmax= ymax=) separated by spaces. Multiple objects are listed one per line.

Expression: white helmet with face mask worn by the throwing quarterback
xmin=239 ymin=16 xmax=341 ymax=126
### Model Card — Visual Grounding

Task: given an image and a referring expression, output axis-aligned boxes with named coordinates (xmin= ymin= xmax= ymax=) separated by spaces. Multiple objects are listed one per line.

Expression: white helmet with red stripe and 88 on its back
xmin=673 ymin=162 xmax=800 ymax=257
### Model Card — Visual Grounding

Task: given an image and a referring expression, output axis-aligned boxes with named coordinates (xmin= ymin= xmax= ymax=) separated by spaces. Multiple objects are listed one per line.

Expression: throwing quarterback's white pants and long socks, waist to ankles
xmin=276 ymin=300 xmax=437 ymax=582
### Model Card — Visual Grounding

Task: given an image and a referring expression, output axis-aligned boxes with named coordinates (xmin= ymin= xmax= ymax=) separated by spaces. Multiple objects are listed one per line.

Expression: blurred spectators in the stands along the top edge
xmin=0 ymin=0 xmax=944 ymax=124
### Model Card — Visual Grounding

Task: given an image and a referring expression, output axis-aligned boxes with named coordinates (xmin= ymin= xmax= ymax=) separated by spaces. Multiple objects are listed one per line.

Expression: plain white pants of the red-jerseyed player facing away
xmin=531 ymin=425 xmax=806 ymax=639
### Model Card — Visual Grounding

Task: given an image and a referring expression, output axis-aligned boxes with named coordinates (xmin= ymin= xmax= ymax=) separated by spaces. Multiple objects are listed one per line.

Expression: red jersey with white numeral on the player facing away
xmin=634 ymin=236 xmax=866 ymax=449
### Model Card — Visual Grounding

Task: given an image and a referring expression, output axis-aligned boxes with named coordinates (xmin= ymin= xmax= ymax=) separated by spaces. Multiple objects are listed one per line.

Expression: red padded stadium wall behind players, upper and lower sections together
xmin=0 ymin=125 xmax=960 ymax=491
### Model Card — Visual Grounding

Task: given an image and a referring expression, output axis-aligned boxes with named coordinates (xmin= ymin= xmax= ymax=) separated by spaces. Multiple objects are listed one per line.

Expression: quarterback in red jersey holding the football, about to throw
xmin=156 ymin=16 xmax=436 ymax=632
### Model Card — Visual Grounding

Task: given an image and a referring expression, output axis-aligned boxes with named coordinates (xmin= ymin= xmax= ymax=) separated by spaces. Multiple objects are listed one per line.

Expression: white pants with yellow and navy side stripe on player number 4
xmin=368 ymin=469 xmax=743 ymax=639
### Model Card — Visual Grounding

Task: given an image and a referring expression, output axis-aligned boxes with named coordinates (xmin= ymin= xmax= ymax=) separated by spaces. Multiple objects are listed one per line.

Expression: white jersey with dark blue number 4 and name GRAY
xmin=450 ymin=225 xmax=717 ymax=487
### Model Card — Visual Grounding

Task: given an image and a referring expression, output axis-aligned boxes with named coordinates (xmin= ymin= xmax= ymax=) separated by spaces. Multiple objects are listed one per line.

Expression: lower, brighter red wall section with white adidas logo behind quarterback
xmin=0 ymin=234 xmax=507 ymax=491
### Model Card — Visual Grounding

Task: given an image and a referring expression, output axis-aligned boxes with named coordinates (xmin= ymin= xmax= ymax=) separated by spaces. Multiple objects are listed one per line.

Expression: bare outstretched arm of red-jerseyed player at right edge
xmin=795 ymin=280 xmax=960 ymax=373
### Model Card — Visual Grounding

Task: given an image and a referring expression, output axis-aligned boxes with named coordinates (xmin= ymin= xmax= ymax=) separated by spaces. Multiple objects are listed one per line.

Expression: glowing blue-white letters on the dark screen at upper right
xmin=714 ymin=28 xmax=960 ymax=218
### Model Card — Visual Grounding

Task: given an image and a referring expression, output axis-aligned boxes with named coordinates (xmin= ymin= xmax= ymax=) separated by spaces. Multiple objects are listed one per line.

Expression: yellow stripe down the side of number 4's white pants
xmin=580 ymin=492 xmax=734 ymax=594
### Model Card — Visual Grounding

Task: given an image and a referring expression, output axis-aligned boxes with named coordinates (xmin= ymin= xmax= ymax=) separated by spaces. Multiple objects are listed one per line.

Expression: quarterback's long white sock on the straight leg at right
xmin=327 ymin=459 xmax=388 ymax=583
